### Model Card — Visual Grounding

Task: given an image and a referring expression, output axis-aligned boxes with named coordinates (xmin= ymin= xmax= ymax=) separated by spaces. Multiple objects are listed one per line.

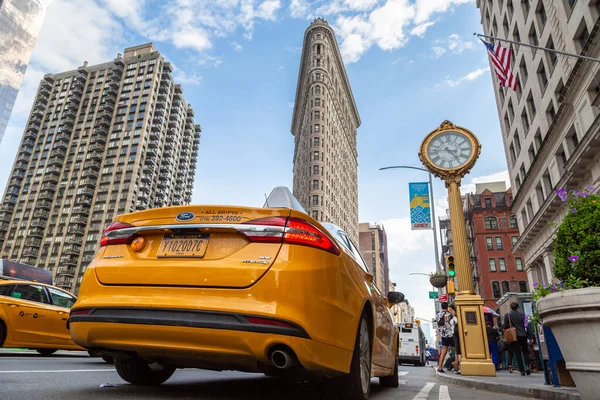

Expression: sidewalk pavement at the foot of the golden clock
xmin=436 ymin=371 xmax=581 ymax=400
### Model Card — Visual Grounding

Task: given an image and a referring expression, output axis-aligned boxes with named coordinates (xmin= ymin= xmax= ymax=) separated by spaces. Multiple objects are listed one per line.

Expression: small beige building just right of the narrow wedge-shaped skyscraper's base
xmin=359 ymin=222 xmax=390 ymax=295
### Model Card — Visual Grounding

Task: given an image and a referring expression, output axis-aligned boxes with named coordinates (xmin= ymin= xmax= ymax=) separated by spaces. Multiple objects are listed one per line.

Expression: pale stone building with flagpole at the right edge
xmin=477 ymin=0 xmax=600 ymax=284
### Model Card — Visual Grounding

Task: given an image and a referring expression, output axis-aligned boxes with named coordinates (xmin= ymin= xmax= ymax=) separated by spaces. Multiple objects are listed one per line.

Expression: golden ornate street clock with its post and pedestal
xmin=419 ymin=121 xmax=496 ymax=376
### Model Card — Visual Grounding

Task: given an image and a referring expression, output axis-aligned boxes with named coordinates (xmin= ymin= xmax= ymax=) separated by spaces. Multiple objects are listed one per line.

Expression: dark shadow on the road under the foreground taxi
xmin=77 ymin=377 xmax=395 ymax=400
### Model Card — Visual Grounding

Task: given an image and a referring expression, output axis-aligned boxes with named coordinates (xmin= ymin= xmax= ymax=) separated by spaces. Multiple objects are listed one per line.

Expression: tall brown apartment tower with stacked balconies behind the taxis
xmin=0 ymin=44 xmax=201 ymax=291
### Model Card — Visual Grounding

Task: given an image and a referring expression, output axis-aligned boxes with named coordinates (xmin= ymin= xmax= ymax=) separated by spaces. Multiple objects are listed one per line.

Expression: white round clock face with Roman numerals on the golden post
xmin=427 ymin=131 xmax=473 ymax=169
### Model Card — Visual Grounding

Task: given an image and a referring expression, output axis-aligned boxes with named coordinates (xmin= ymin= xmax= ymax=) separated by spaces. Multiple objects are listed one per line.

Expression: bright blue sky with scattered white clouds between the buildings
xmin=0 ymin=0 xmax=507 ymax=336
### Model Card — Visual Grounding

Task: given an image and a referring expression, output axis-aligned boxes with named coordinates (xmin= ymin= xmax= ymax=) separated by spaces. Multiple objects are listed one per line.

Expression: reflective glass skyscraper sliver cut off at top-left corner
xmin=0 ymin=0 xmax=51 ymax=143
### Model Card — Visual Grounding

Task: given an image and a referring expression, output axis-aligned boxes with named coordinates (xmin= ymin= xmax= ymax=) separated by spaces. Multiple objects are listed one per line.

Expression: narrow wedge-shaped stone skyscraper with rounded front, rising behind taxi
xmin=291 ymin=18 xmax=360 ymax=243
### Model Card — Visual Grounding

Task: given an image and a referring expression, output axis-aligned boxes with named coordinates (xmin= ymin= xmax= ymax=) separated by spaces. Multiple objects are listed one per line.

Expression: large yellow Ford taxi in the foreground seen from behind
xmin=69 ymin=187 xmax=404 ymax=399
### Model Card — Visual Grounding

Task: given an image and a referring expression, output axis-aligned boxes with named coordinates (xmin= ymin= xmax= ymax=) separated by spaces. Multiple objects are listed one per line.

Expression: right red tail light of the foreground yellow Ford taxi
xmin=243 ymin=217 xmax=340 ymax=256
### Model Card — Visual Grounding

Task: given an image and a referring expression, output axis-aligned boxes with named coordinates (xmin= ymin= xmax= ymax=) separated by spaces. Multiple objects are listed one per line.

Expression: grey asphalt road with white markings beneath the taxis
xmin=0 ymin=349 xmax=536 ymax=400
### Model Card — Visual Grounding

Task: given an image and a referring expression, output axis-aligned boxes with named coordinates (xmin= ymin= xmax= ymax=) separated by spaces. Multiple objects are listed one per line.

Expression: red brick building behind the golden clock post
xmin=464 ymin=182 xmax=529 ymax=310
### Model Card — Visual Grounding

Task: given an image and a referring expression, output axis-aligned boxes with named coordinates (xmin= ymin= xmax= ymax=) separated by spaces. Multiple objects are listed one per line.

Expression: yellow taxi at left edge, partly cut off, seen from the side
xmin=0 ymin=280 xmax=83 ymax=356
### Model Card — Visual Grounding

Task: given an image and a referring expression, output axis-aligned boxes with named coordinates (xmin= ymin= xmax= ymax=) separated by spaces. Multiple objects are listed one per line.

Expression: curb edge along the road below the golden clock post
xmin=435 ymin=371 xmax=581 ymax=400
